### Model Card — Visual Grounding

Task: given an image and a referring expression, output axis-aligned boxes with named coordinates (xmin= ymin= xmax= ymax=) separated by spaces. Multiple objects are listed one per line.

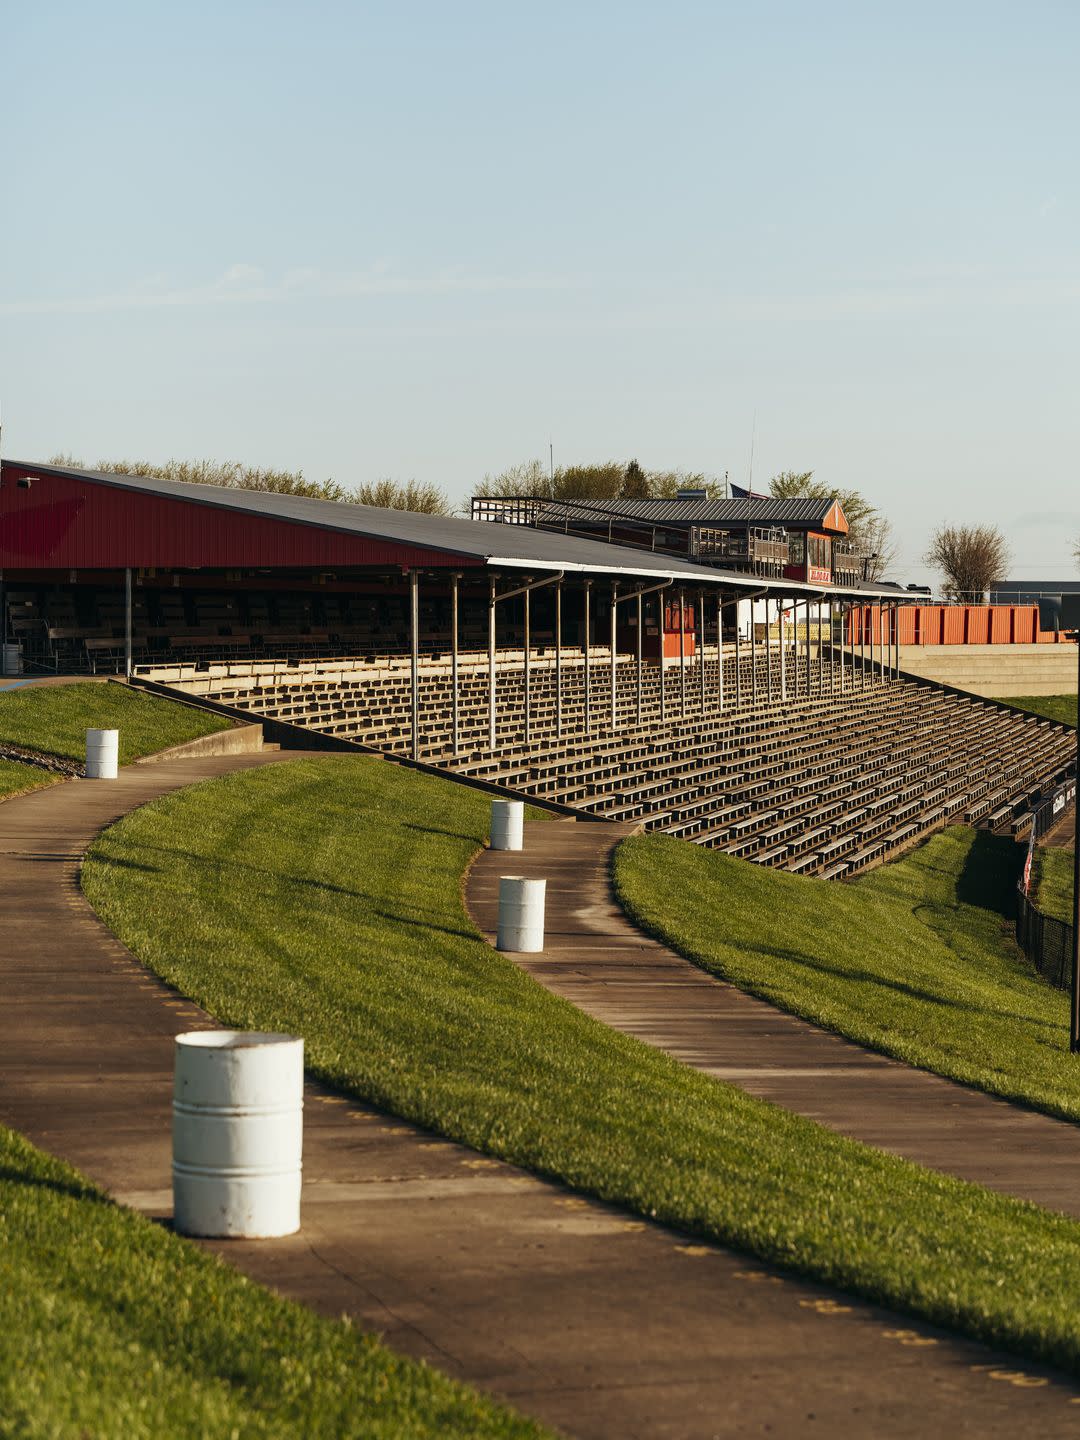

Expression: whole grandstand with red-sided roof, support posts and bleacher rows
xmin=0 ymin=462 xmax=1074 ymax=877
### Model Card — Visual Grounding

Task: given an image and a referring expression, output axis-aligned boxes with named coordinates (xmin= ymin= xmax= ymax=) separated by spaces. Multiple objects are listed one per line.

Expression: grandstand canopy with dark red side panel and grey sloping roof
xmin=0 ymin=461 xmax=897 ymax=598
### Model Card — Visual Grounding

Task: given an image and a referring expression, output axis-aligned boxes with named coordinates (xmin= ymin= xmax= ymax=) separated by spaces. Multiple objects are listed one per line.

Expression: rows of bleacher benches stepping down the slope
xmin=161 ymin=654 xmax=1076 ymax=877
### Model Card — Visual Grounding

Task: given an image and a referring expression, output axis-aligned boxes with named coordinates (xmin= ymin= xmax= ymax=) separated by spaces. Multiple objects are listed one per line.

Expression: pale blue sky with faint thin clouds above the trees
xmin=0 ymin=0 xmax=1080 ymax=582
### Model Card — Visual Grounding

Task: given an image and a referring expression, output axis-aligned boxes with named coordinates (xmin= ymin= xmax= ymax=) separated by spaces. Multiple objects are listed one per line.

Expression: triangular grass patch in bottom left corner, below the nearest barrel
xmin=0 ymin=1126 xmax=546 ymax=1440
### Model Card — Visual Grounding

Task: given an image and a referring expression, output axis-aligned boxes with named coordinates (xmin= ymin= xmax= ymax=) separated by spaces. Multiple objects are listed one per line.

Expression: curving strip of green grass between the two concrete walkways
xmin=84 ymin=756 xmax=1080 ymax=1374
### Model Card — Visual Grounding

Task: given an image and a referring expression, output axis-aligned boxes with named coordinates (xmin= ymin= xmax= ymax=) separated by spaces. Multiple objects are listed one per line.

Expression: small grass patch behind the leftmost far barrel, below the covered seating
xmin=0 ymin=683 xmax=229 ymax=765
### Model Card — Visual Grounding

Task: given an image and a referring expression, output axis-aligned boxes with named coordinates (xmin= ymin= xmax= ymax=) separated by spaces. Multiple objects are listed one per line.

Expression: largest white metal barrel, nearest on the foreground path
xmin=173 ymin=1030 xmax=304 ymax=1240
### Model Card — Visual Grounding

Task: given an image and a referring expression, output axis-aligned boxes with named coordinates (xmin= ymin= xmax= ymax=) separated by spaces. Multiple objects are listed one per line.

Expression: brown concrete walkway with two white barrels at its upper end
xmin=467 ymin=821 xmax=1080 ymax=1217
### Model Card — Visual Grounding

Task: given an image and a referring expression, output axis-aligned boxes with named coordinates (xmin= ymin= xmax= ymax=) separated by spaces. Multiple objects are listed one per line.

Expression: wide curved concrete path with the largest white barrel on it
xmin=0 ymin=756 xmax=1080 ymax=1440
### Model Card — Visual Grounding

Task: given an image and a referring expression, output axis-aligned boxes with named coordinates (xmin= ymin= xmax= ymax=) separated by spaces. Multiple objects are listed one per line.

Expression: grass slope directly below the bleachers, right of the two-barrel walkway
xmin=615 ymin=825 xmax=1080 ymax=1120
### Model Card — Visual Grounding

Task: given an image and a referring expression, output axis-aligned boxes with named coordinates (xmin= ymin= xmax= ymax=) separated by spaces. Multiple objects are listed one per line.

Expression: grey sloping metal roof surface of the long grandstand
xmin=3 ymin=461 xmax=898 ymax=595
